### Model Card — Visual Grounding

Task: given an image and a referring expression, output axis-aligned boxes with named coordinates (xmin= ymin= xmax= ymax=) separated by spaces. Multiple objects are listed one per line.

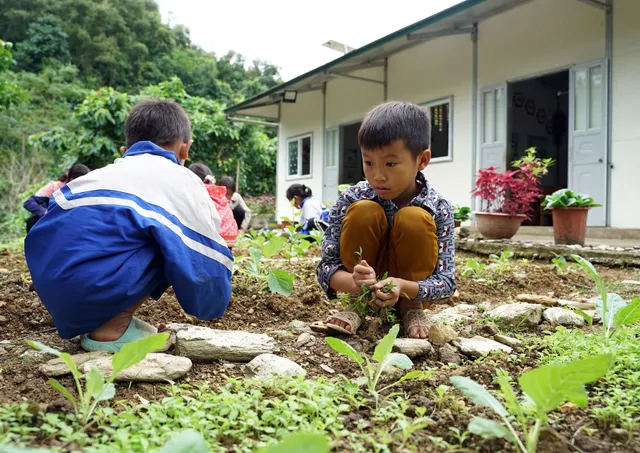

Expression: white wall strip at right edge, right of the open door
xmin=611 ymin=0 xmax=640 ymax=228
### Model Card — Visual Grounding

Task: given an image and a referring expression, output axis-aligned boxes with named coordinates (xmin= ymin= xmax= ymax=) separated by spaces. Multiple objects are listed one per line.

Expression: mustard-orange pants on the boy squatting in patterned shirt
xmin=340 ymin=200 xmax=438 ymax=306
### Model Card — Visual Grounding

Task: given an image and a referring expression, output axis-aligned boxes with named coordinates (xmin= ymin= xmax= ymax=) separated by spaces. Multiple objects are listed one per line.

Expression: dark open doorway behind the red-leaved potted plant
xmin=507 ymin=70 xmax=570 ymax=226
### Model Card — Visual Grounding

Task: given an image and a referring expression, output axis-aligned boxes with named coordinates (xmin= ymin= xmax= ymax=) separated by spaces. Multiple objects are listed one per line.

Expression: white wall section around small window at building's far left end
xmin=276 ymin=91 xmax=322 ymax=217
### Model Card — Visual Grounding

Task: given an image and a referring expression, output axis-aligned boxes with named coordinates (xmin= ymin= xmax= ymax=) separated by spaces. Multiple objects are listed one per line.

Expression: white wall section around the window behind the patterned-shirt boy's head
xmin=388 ymin=35 xmax=473 ymax=206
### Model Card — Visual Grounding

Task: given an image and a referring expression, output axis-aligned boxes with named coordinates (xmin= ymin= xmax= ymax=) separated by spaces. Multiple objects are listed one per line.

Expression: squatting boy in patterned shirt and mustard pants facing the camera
xmin=318 ymin=102 xmax=456 ymax=338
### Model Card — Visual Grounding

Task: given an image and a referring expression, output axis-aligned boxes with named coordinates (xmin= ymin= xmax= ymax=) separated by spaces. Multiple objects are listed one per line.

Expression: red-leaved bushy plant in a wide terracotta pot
xmin=472 ymin=148 xmax=554 ymax=239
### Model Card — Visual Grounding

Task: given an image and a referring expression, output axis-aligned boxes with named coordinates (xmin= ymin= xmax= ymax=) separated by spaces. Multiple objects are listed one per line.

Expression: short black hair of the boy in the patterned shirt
xmin=358 ymin=102 xmax=431 ymax=157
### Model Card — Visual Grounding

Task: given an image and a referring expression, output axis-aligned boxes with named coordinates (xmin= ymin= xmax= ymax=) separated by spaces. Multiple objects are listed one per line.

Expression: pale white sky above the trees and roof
xmin=156 ymin=0 xmax=461 ymax=81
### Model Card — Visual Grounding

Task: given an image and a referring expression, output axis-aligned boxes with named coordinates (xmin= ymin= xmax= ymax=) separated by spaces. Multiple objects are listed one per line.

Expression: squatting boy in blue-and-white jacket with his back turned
xmin=25 ymin=100 xmax=233 ymax=351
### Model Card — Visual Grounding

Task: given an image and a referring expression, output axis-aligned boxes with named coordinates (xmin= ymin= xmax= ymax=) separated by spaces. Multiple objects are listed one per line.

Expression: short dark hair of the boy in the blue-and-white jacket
xmin=124 ymin=99 xmax=191 ymax=148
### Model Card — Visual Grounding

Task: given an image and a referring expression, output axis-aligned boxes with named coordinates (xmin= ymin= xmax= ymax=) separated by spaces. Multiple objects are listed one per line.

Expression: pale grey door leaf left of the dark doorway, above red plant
xmin=480 ymin=85 xmax=507 ymax=172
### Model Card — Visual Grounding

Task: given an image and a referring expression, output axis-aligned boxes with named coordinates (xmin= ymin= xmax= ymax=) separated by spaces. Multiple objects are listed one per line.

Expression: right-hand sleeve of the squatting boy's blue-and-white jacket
xmin=153 ymin=178 xmax=233 ymax=320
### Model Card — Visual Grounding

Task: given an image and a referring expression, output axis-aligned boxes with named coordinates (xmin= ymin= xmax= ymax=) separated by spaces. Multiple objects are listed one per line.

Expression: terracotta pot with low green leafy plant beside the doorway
xmin=542 ymin=189 xmax=601 ymax=245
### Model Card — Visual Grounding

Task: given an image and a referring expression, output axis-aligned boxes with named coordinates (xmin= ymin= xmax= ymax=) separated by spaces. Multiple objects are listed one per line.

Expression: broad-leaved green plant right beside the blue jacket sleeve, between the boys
xmin=238 ymin=236 xmax=295 ymax=296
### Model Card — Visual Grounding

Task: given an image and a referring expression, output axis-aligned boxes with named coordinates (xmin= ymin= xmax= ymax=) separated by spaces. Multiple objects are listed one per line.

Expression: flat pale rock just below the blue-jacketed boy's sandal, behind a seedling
xmin=79 ymin=352 xmax=191 ymax=382
